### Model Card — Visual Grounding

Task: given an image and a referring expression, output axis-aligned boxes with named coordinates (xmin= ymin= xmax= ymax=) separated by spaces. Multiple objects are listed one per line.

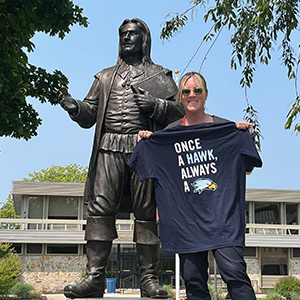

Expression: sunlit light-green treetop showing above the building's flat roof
xmin=23 ymin=164 xmax=88 ymax=182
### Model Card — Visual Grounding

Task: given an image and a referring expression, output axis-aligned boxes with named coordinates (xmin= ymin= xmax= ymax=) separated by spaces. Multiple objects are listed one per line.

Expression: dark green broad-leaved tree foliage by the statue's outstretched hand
xmin=0 ymin=0 xmax=88 ymax=140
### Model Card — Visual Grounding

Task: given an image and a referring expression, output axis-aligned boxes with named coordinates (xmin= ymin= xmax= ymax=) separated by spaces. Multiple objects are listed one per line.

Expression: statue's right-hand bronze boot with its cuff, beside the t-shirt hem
xmin=135 ymin=220 xmax=168 ymax=298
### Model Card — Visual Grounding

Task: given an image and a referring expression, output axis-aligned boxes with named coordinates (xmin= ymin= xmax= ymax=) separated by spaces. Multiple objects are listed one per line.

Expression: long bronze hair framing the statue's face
xmin=118 ymin=18 xmax=153 ymax=64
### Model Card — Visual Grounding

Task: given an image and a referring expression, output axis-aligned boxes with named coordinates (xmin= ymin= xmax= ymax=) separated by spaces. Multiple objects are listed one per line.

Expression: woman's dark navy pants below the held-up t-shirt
xmin=179 ymin=247 xmax=256 ymax=300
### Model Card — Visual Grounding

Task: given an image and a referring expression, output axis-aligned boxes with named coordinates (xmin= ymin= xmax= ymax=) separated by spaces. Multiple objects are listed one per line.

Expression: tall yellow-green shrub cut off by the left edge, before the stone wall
xmin=0 ymin=242 xmax=22 ymax=298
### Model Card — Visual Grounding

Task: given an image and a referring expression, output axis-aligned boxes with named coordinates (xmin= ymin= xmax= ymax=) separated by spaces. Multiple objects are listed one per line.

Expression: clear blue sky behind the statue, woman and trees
xmin=0 ymin=0 xmax=300 ymax=202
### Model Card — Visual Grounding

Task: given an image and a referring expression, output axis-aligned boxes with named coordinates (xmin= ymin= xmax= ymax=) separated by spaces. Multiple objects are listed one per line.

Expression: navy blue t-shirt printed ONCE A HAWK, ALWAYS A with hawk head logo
xmin=128 ymin=122 xmax=262 ymax=253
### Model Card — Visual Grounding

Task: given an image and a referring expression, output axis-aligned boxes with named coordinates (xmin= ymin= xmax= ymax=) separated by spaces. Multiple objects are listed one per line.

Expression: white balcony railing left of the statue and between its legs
xmin=0 ymin=218 xmax=134 ymax=231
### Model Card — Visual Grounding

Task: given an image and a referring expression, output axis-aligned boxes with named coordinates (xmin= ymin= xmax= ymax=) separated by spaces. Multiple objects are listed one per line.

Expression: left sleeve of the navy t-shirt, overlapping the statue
xmin=128 ymin=139 xmax=156 ymax=181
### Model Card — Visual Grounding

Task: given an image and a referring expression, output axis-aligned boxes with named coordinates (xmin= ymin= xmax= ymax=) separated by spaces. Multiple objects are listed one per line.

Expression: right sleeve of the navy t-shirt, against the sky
xmin=239 ymin=130 xmax=262 ymax=172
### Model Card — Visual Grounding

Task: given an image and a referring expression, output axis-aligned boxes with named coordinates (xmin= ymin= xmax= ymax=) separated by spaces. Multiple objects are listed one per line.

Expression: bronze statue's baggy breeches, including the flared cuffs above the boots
xmin=85 ymin=150 xmax=160 ymax=245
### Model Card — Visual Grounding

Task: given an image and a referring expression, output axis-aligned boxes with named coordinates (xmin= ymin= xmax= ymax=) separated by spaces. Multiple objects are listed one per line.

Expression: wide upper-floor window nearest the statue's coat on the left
xmin=48 ymin=196 xmax=79 ymax=220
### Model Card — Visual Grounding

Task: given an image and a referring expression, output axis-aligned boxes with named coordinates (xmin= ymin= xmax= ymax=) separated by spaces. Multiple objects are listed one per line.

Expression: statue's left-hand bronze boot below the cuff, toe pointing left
xmin=64 ymin=241 xmax=112 ymax=299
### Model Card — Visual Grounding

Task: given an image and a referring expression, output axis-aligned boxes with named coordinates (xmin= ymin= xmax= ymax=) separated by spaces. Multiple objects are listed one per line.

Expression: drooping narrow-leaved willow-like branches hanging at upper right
xmin=161 ymin=0 xmax=300 ymax=146
